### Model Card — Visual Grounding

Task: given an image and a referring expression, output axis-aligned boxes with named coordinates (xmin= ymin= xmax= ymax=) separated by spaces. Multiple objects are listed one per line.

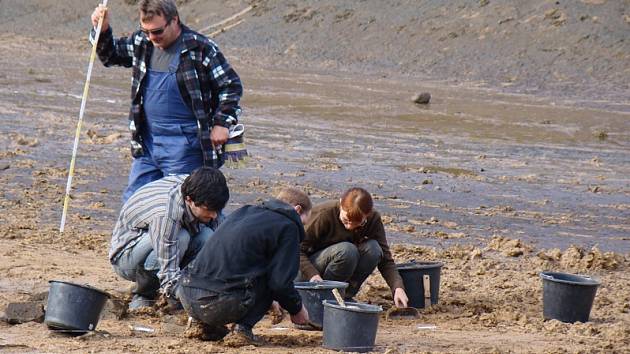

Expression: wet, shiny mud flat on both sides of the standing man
xmin=0 ymin=43 xmax=630 ymax=252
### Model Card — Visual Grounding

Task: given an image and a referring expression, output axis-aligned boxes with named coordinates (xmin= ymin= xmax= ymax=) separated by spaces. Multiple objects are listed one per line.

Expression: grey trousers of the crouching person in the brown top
xmin=300 ymin=240 xmax=383 ymax=298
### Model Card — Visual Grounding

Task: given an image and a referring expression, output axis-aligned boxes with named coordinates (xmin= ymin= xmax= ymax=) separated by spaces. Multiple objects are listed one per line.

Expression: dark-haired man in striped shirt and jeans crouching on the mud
xmin=109 ymin=167 xmax=230 ymax=309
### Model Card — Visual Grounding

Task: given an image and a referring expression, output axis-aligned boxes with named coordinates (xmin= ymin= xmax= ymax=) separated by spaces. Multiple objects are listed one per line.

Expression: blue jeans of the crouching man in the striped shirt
xmin=112 ymin=225 xmax=214 ymax=298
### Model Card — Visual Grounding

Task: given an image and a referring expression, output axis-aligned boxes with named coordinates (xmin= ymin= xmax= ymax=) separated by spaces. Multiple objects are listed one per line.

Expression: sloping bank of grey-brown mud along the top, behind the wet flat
xmin=0 ymin=0 xmax=630 ymax=112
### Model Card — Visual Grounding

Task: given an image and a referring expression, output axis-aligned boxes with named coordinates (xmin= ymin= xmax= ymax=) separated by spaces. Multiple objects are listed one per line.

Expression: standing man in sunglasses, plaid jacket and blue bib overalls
xmin=90 ymin=0 xmax=243 ymax=202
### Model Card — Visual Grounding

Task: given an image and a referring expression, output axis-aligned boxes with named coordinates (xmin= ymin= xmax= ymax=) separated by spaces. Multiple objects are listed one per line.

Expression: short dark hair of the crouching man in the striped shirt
xmin=182 ymin=167 xmax=230 ymax=211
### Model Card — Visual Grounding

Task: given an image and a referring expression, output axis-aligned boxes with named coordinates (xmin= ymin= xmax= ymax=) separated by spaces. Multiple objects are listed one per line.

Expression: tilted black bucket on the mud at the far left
xmin=44 ymin=280 xmax=109 ymax=333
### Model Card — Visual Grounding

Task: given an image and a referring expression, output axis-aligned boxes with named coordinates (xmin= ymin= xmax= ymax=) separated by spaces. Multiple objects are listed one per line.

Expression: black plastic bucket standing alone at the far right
xmin=540 ymin=272 xmax=601 ymax=323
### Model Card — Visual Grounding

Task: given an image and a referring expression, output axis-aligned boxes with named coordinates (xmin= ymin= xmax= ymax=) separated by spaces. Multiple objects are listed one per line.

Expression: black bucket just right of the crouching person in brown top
xmin=396 ymin=261 xmax=444 ymax=308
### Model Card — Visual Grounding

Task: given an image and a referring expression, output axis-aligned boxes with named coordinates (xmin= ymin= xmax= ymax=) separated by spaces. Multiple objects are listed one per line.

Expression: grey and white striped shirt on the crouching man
xmin=109 ymin=175 xmax=199 ymax=286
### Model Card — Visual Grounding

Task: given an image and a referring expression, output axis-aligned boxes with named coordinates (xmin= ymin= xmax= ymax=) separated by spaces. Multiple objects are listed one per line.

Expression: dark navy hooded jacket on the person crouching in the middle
xmin=182 ymin=199 xmax=304 ymax=314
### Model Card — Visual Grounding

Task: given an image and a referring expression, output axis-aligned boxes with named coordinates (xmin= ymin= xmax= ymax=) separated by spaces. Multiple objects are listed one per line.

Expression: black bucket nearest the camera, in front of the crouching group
xmin=323 ymin=300 xmax=383 ymax=353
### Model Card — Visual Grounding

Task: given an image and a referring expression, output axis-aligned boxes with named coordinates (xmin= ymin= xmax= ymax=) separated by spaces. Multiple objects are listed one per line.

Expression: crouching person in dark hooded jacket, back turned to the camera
xmin=177 ymin=188 xmax=312 ymax=340
